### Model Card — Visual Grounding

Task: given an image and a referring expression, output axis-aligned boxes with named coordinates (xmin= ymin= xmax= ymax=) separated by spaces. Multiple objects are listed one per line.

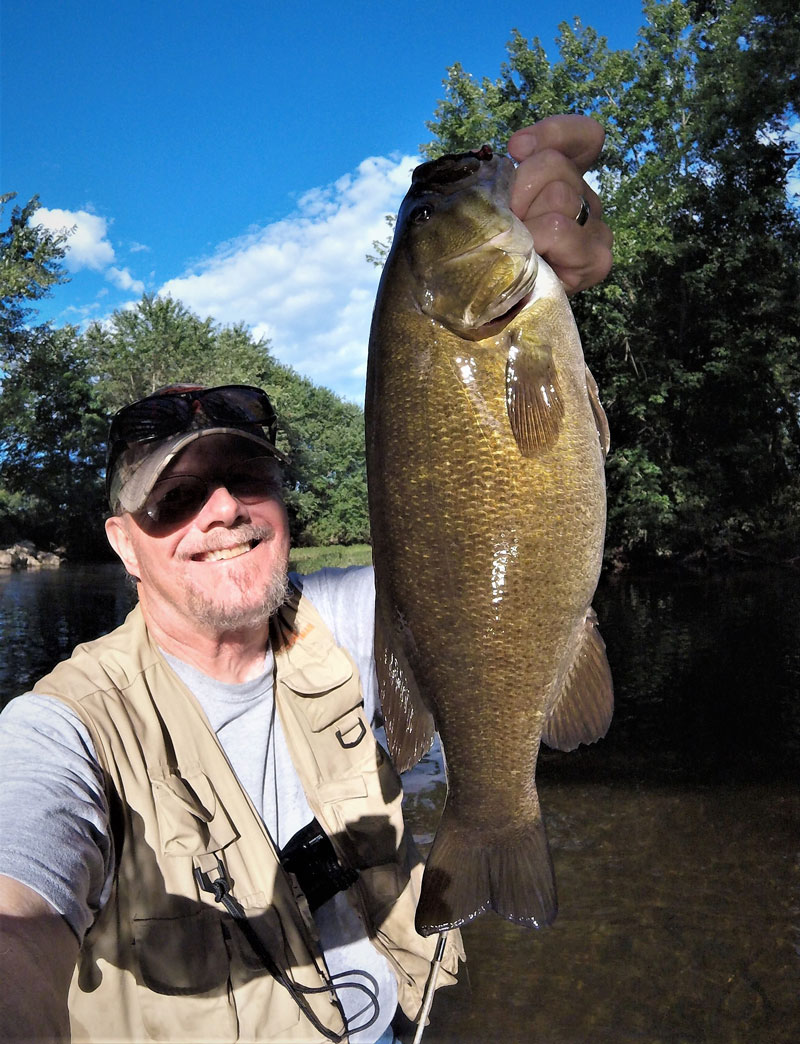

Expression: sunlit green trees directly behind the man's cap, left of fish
xmin=83 ymin=294 xmax=369 ymax=544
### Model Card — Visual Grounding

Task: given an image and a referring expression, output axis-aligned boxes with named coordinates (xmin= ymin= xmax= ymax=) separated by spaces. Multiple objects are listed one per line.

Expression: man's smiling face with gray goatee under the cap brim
xmin=105 ymin=435 xmax=289 ymax=640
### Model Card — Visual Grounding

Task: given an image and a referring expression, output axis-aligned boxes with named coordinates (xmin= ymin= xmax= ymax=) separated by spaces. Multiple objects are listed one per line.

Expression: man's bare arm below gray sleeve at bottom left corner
xmin=0 ymin=874 xmax=78 ymax=1041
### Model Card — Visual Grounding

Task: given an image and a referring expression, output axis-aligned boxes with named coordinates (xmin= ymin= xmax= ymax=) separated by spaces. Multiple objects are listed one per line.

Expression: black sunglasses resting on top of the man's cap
xmin=105 ymin=384 xmax=278 ymax=491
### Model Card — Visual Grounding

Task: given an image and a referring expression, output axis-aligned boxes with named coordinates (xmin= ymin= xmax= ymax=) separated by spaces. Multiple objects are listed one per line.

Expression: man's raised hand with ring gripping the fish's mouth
xmin=509 ymin=116 xmax=613 ymax=293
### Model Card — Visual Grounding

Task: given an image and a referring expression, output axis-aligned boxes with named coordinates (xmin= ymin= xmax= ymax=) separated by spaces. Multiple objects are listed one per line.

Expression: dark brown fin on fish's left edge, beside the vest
xmin=375 ymin=613 xmax=436 ymax=773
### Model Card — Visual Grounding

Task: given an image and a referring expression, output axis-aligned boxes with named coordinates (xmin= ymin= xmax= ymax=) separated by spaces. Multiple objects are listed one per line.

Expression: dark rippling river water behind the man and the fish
xmin=0 ymin=566 xmax=800 ymax=1044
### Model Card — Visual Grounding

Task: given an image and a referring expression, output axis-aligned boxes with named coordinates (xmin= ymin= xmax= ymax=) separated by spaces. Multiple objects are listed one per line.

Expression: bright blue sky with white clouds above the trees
xmin=0 ymin=0 xmax=642 ymax=402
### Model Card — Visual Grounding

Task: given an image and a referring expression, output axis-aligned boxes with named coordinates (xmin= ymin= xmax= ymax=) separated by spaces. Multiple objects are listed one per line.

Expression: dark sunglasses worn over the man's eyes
xmin=138 ymin=456 xmax=281 ymax=529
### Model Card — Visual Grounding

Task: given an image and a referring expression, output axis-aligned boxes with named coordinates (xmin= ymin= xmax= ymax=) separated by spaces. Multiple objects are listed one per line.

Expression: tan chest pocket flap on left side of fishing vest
xmin=151 ymin=773 xmax=238 ymax=855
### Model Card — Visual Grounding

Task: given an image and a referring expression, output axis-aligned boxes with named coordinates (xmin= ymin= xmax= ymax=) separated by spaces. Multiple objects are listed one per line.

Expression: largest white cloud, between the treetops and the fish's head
xmin=160 ymin=156 xmax=419 ymax=399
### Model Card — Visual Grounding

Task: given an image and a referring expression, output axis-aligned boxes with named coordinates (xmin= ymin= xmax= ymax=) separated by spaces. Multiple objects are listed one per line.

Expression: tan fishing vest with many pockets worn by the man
xmin=34 ymin=591 xmax=463 ymax=1044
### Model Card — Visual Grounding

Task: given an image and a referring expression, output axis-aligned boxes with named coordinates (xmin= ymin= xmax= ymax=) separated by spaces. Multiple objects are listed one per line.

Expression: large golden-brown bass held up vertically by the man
xmin=364 ymin=146 xmax=613 ymax=935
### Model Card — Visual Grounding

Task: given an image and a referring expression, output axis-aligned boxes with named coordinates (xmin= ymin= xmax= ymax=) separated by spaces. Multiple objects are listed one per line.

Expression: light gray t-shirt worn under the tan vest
xmin=0 ymin=568 xmax=397 ymax=1044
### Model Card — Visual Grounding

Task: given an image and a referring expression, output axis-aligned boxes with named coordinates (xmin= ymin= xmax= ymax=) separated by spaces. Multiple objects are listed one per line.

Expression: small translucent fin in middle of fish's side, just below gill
xmin=505 ymin=338 xmax=564 ymax=457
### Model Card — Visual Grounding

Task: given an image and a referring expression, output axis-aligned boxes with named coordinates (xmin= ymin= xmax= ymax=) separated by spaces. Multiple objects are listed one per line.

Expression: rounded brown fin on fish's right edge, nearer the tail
xmin=542 ymin=609 xmax=614 ymax=751
